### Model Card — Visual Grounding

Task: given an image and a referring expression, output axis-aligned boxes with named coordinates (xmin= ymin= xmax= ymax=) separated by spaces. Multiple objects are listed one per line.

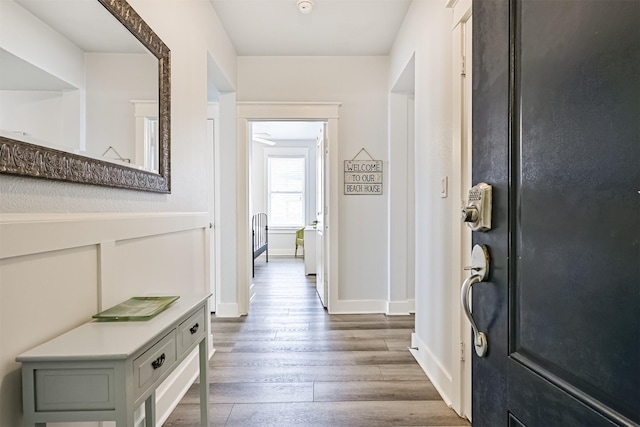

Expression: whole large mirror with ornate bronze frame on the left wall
xmin=0 ymin=0 xmax=171 ymax=193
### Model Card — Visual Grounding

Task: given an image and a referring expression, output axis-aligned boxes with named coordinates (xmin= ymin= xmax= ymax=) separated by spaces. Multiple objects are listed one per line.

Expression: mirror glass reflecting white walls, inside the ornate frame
xmin=0 ymin=0 xmax=159 ymax=172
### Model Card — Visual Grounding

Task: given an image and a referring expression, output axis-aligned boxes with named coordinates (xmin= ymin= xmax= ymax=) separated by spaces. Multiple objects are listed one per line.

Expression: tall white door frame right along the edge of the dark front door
xmin=442 ymin=0 xmax=472 ymax=420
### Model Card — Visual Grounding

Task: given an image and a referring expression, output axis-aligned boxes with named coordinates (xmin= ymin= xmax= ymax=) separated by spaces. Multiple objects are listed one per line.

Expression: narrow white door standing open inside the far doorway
xmin=316 ymin=123 xmax=328 ymax=307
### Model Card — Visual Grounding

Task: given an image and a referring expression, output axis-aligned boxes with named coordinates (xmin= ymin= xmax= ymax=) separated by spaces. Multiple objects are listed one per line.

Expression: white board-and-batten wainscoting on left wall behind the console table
xmin=0 ymin=212 xmax=213 ymax=426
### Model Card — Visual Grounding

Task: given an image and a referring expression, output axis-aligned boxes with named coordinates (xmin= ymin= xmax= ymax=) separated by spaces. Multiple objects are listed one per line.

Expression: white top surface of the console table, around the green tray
xmin=16 ymin=293 xmax=211 ymax=362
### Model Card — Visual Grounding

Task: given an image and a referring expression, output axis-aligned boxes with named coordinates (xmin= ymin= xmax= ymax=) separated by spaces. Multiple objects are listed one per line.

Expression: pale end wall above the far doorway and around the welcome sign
xmin=237 ymin=57 xmax=389 ymax=312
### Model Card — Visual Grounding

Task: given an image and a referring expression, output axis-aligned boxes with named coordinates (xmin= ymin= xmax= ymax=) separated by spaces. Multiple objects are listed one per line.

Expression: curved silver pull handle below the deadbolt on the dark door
xmin=460 ymin=245 xmax=489 ymax=357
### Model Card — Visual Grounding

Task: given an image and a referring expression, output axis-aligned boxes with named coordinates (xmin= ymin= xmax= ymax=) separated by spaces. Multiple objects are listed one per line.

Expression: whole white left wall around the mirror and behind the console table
xmin=0 ymin=0 xmax=236 ymax=427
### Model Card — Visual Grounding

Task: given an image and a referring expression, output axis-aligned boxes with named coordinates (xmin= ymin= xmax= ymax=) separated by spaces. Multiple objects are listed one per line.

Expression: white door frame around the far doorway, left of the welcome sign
xmin=236 ymin=102 xmax=341 ymax=314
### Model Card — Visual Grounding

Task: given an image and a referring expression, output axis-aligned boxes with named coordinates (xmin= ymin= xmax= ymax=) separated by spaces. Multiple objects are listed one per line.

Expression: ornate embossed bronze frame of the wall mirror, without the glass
xmin=0 ymin=0 xmax=171 ymax=193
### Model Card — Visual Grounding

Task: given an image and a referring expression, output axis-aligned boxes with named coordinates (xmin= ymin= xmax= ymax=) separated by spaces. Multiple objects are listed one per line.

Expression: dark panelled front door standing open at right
xmin=472 ymin=0 xmax=640 ymax=427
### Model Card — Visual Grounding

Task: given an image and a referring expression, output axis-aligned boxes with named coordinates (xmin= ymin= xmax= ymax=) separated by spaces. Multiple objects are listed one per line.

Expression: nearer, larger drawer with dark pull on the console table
xmin=133 ymin=330 xmax=176 ymax=395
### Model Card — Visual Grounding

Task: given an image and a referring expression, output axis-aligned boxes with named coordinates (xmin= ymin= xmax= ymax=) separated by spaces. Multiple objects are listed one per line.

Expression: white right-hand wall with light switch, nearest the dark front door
xmin=389 ymin=0 xmax=459 ymax=401
